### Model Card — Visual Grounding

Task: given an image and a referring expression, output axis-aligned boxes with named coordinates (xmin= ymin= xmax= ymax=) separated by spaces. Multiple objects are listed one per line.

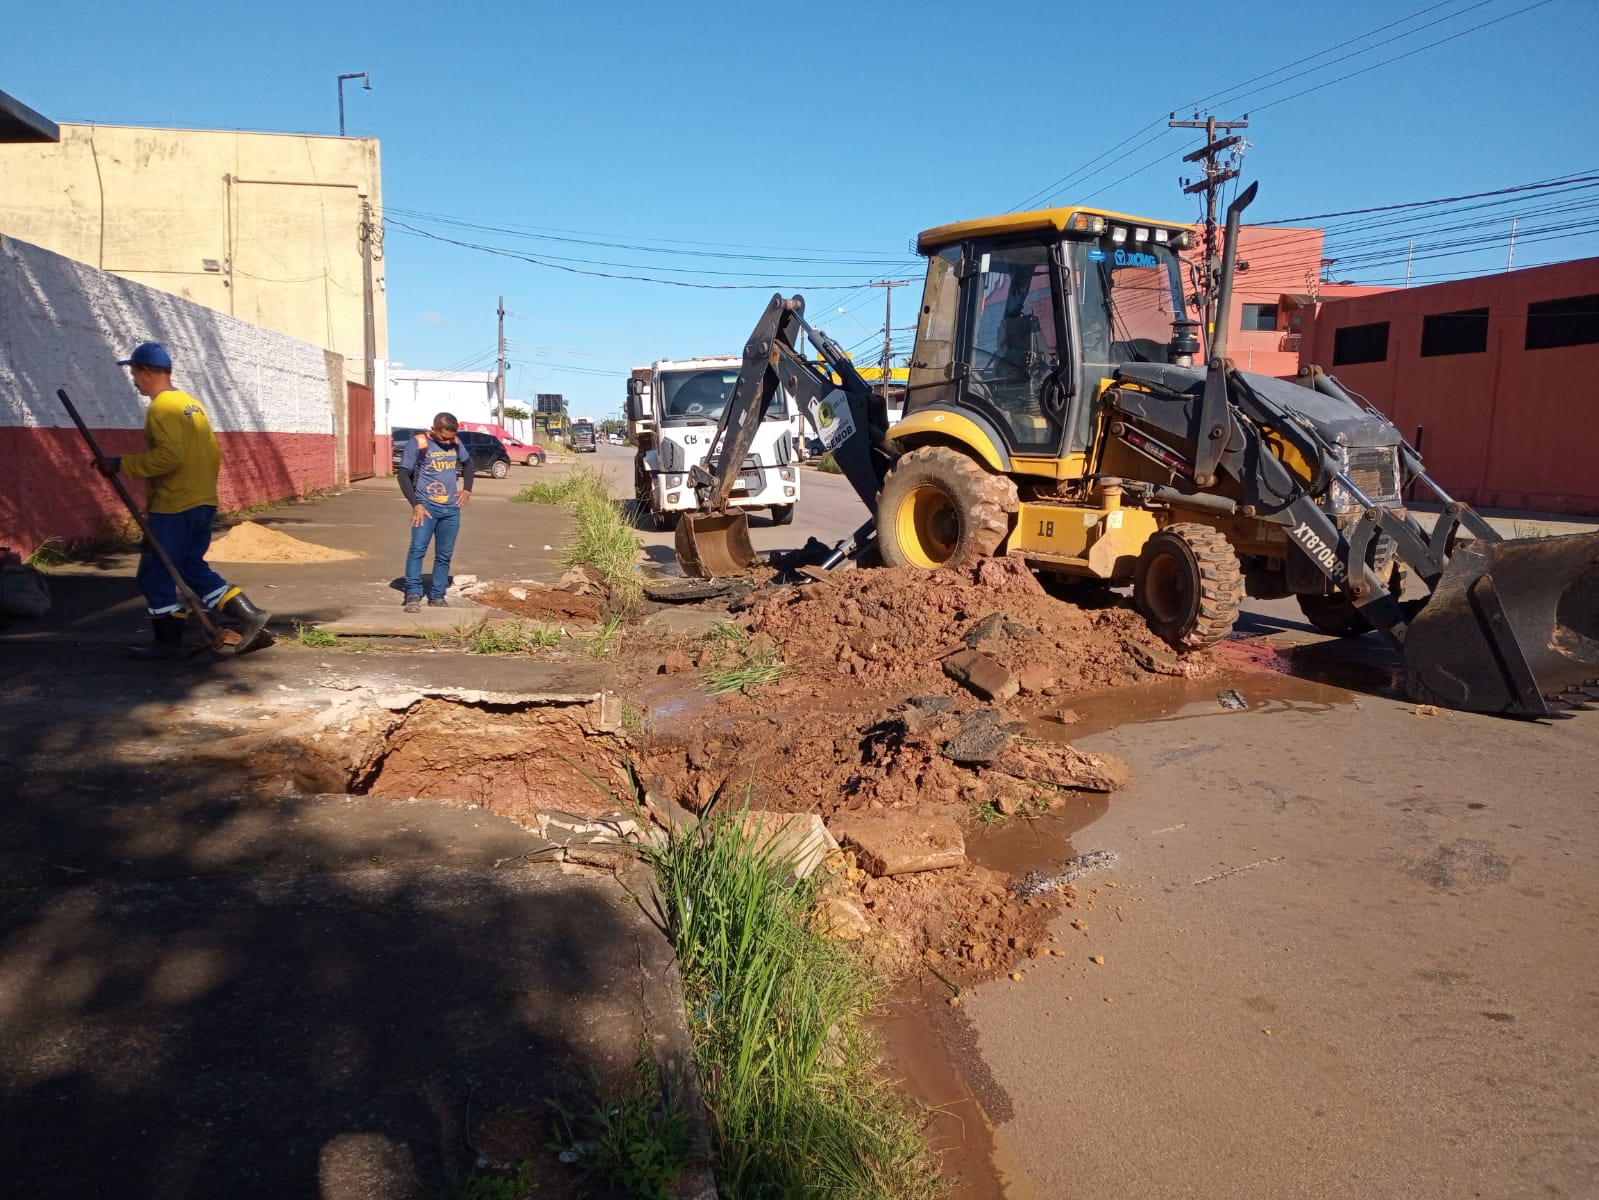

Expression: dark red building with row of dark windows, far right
xmin=1304 ymin=258 xmax=1599 ymax=514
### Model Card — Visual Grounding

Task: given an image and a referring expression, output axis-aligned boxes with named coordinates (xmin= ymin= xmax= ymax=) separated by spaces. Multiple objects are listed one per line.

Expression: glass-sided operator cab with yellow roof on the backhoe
xmin=907 ymin=210 xmax=1188 ymax=475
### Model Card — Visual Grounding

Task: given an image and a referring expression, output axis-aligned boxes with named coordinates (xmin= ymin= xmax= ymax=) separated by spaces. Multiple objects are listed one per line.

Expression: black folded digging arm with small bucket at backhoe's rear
xmin=675 ymin=294 xmax=894 ymax=579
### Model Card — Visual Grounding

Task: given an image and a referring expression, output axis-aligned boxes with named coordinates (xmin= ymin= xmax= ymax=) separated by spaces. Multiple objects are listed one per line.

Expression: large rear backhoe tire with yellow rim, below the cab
xmin=876 ymin=446 xmax=1017 ymax=571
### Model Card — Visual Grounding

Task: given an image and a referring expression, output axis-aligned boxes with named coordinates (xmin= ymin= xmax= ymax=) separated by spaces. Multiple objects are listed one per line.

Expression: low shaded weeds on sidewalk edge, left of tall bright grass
xmin=552 ymin=1051 xmax=694 ymax=1200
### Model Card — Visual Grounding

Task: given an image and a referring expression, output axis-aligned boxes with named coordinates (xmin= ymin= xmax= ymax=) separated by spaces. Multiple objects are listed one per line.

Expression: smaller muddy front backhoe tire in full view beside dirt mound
xmin=1132 ymin=523 xmax=1244 ymax=650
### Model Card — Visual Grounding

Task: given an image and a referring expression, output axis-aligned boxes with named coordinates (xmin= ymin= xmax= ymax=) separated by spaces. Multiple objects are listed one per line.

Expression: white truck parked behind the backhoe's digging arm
xmin=627 ymin=355 xmax=800 ymax=530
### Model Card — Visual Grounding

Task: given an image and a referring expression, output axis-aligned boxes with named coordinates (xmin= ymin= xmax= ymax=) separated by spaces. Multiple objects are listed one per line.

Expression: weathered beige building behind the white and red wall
xmin=0 ymin=125 xmax=389 ymax=382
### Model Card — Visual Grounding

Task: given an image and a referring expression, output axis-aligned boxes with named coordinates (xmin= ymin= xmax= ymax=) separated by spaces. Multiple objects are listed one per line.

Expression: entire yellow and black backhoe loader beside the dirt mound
xmin=676 ymin=186 xmax=1599 ymax=717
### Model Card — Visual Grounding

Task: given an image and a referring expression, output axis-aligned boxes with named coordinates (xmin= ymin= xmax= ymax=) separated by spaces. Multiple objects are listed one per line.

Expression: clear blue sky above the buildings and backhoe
xmin=0 ymin=0 xmax=1599 ymax=418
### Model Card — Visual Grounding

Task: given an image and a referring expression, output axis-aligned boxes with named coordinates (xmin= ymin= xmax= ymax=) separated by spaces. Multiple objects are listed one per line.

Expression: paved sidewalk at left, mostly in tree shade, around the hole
xmin=0 ymin=470 xmax=704 ymax=1200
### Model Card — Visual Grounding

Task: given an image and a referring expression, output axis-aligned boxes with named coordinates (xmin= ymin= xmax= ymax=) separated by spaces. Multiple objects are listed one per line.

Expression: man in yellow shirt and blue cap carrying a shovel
xmin=94 ymin=342 xmax=272 ymax=659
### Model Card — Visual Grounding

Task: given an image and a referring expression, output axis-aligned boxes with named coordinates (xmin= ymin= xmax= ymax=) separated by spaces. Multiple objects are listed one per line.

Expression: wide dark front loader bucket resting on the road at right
xmin=1404 ymin=533 xmax=1599 ymax=717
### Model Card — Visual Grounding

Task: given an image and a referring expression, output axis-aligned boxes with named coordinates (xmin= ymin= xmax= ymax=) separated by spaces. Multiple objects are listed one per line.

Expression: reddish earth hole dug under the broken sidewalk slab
xmin=345 ymin=698 xmax=630 ymax=826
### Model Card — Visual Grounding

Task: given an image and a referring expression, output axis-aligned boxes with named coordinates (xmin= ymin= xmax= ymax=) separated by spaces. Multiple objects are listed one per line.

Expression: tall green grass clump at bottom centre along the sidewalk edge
xmin=651 ymin=810 xmax=942 ymax=1200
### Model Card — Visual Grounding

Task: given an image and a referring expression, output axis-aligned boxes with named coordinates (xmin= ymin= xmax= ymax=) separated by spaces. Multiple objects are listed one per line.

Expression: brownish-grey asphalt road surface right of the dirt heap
xmin=569 ymin=446 xmax=1599 ymax=1200
